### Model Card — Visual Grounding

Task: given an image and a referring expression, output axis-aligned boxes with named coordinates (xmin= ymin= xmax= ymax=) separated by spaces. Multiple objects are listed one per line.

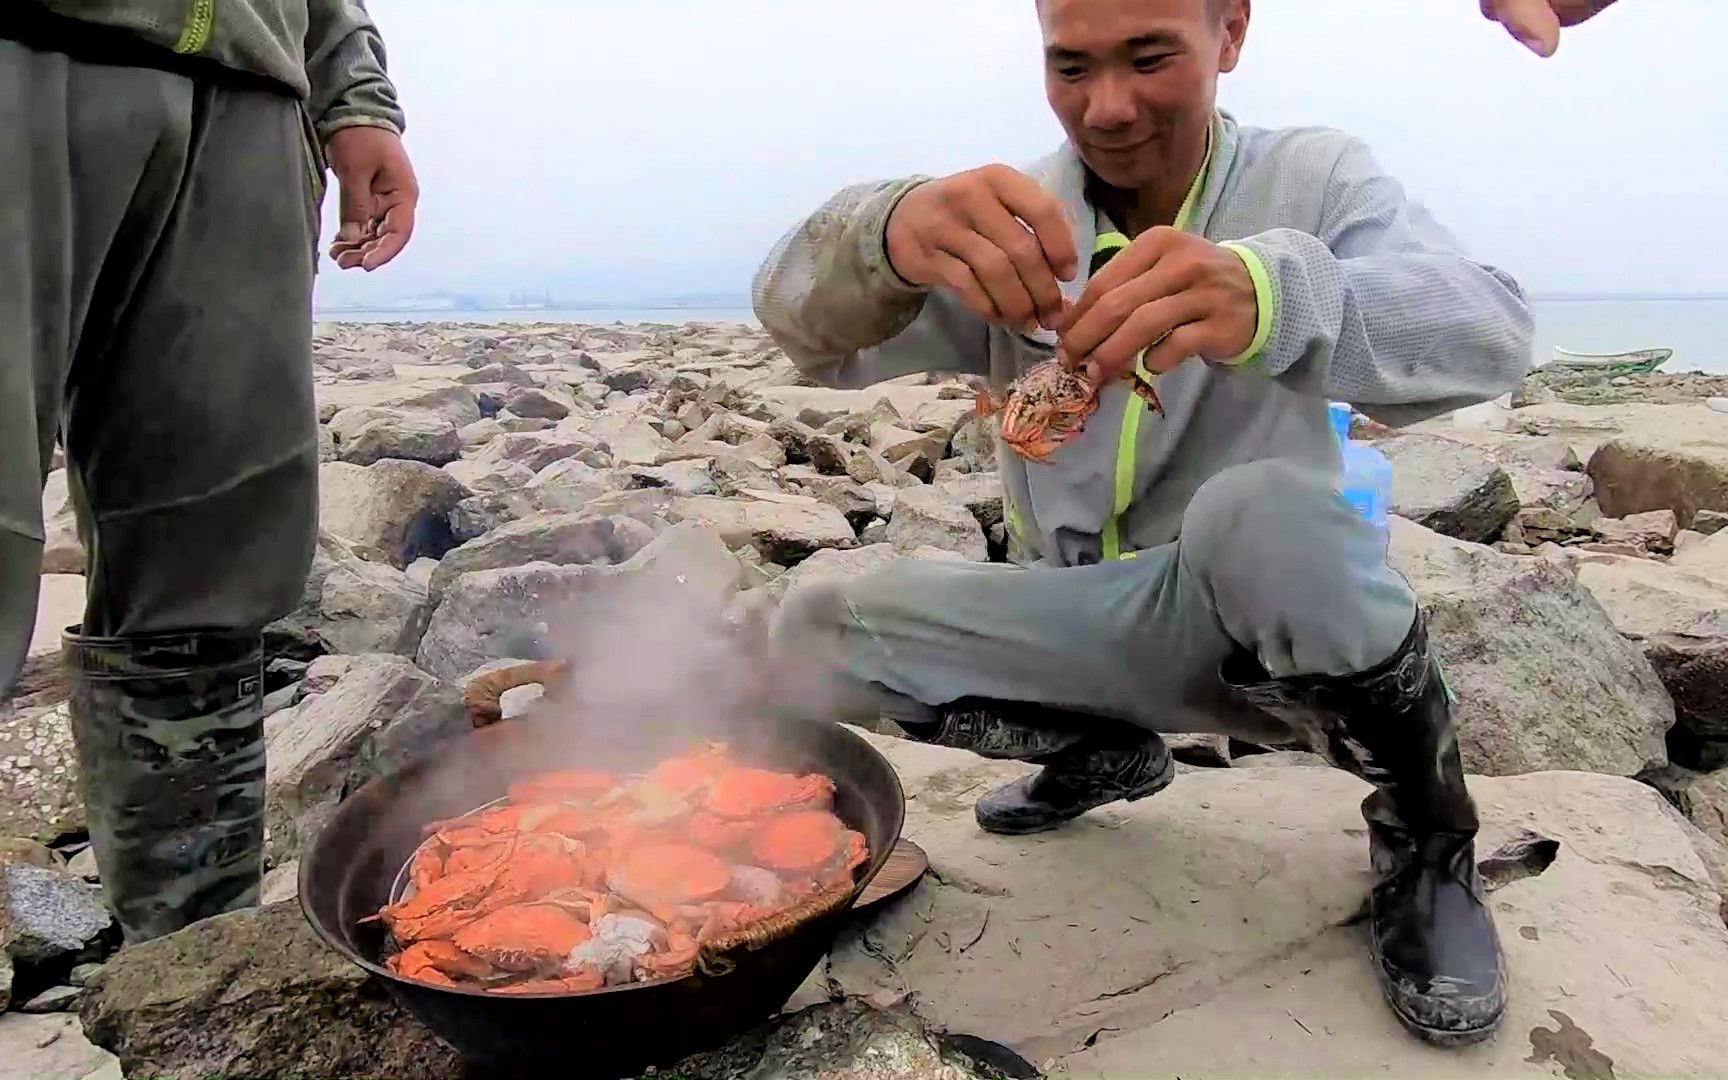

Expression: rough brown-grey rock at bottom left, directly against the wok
xmin=81 ymin=902 xmax=463 ymax=1080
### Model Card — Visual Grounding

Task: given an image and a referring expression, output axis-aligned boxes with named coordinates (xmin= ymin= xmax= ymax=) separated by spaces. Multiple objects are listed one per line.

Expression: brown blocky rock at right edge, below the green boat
xmin=1590 ymin=437 xmax=1728 ymax=529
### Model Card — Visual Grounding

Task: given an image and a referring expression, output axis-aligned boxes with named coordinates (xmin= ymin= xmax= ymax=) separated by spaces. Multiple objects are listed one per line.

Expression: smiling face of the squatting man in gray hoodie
xmin=1039 ymin=0 xmax=1249 ymax=188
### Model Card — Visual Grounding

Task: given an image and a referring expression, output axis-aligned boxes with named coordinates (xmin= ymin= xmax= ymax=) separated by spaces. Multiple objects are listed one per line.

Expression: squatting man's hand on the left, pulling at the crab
xmin=888 ymin=164 xmax=1080 ymax=330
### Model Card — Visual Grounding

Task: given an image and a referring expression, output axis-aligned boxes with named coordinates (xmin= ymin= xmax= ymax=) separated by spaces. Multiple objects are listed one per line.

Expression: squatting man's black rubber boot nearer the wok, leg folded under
xmin=919 ymin=698 xmax=1177 ymax=836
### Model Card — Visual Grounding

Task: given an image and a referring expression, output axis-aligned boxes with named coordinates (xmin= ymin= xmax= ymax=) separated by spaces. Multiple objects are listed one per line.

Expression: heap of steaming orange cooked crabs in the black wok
xmin=363 ymin=743 xmax=869 ymax=994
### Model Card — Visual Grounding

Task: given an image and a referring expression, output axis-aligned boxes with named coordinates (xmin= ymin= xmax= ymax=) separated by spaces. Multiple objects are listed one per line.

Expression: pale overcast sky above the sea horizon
xmin=318 ymin=0 xmax=1728 ymax=304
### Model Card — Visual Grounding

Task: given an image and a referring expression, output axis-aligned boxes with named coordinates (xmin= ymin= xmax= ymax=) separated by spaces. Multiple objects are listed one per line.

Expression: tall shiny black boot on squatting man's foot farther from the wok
xmin=1222 ymin=613 xmax=1505 ymax=1045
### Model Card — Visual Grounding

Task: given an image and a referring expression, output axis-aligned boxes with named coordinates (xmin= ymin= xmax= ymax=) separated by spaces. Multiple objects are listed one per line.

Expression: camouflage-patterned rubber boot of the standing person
xmin=64 ymin=629 xmax=264 ymax=943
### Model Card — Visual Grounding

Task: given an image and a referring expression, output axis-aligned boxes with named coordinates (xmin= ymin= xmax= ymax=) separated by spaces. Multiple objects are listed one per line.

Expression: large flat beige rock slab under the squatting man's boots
xmin=819 ymin=734 xmax=1728 ymax=1080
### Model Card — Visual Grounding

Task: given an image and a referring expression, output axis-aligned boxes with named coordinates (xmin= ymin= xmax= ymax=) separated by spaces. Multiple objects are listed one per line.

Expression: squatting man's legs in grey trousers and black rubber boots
xmin=774 ymin=461 xmax=1503 ymax=1042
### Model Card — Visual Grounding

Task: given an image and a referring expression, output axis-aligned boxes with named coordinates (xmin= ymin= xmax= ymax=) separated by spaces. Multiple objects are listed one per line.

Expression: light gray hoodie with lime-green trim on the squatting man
xmin=753 ymin=111 xmax=1531 ymax=565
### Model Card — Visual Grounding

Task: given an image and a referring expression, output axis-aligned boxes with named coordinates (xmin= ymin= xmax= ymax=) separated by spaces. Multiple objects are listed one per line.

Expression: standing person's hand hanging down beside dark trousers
xmin=328 ymin=126 xmax=420 ymax=270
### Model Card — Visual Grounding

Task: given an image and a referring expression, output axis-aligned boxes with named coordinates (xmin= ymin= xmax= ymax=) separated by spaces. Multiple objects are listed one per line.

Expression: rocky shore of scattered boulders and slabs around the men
xmin=0 ymin=323 xmax=1728 ymax=1080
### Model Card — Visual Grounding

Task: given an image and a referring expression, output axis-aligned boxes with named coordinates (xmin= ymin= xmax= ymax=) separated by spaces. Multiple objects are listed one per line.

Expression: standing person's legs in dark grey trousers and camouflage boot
xmin=0 ymin=41 xmax=318 ymax=942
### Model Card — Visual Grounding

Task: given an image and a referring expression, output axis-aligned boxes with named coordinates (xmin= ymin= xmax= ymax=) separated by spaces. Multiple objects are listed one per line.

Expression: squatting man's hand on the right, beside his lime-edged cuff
xmin=1059 ymin=226 xmax=1260 ymax=382
